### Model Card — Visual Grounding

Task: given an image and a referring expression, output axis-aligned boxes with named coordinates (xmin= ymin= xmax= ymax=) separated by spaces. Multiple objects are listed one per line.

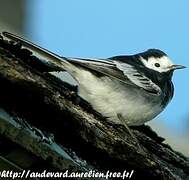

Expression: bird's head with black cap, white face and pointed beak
xmin=138 ymin=49 xmax=185 ymax=74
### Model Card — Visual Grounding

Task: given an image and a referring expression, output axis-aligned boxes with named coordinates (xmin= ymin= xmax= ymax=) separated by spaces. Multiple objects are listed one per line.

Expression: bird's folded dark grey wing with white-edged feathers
xmin=68 ymin=58 xmax=161 ymax=94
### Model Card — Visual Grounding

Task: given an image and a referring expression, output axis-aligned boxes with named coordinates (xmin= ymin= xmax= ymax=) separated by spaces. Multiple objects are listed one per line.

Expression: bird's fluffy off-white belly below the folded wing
xmin=74 ymin=68 xmax=163 ymax=125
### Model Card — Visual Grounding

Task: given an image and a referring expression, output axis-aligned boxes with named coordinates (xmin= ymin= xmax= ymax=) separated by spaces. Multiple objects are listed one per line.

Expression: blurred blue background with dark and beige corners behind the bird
xmin=0 ymin=0 xmax=189 ymax=156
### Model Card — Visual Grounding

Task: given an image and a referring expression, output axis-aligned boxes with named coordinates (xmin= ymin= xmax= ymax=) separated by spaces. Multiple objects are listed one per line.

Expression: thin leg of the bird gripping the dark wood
xmin=117 ymin=113 xmax=144 ymax=152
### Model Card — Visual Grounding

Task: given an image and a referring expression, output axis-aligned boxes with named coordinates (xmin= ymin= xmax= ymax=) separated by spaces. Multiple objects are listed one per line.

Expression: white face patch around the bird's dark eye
xmin=140 ymin=56 xmax=173 ymax=73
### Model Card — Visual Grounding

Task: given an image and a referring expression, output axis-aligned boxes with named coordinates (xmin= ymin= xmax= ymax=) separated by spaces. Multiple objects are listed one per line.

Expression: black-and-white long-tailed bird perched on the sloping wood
xmin=3 ymin=32 xmax=184 ymax=125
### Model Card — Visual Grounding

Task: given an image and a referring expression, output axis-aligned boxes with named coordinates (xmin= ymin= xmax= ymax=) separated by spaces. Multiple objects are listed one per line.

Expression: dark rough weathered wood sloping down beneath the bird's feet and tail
xmin=0 ymin=34 xmax=189 ymax=180
